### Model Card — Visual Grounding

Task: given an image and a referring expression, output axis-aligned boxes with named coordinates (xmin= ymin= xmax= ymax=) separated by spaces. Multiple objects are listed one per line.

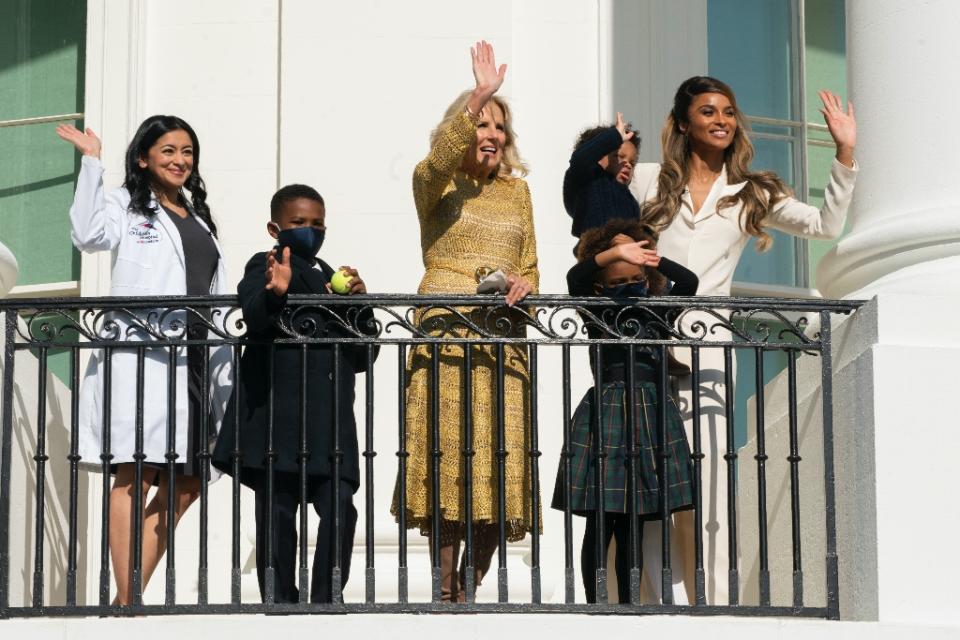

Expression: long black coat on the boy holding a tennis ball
xmin=213 ymin=253 xmax=377 ymax=489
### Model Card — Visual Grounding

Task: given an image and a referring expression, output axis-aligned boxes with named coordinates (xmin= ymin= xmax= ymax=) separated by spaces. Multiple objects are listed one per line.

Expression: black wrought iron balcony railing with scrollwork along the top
xmin=0 ymin=295 xmax=859 ymax=618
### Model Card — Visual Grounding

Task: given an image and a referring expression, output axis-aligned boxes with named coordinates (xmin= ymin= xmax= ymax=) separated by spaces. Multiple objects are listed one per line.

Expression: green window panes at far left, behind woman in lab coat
xmin=0 ymin=0 xmax=86 ymax=285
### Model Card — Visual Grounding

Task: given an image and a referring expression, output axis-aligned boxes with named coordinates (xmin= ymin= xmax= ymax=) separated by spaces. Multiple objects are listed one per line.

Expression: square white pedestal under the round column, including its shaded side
xmin=739 ymin=294 xmax=960 ymax=626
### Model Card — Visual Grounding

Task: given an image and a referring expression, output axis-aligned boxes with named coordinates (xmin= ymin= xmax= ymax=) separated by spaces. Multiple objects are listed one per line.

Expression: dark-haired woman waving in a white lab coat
xmin=57 ymin=116 xmax=231 ymax=605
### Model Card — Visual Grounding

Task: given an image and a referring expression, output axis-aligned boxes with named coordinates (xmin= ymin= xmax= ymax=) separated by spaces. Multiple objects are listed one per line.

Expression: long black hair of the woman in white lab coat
xmin=123 ymin=116 xmax=217 ymax=236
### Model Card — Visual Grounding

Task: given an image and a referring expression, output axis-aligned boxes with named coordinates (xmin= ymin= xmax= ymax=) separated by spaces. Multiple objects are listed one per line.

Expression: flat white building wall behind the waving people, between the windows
xmin=16 ymin=0 xmax=720 ymax=602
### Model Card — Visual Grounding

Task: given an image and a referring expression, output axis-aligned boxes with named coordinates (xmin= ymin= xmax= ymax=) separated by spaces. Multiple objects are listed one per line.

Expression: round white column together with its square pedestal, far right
xmin=817 ymin=0 xmax=960 ymax=629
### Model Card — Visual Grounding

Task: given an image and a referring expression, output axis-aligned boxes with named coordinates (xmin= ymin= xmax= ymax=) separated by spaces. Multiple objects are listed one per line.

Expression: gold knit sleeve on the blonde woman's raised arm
xmin=413 ymin=112 xmax=477 ymax=219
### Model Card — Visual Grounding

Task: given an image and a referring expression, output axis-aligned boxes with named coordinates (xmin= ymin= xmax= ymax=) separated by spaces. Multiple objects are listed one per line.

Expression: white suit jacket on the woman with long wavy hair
xmin=631 ymin=159 xmax=859 ymax=296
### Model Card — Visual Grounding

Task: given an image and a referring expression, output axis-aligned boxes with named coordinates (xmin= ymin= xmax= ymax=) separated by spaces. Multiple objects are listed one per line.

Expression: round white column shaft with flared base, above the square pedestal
xmin=817 ymin=0 xmax=960 ymax=298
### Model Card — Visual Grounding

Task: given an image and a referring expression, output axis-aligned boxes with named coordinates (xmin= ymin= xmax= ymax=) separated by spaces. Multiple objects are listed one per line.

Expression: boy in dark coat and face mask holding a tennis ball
xmin=213 ymin=184 xmax=376 ymax=602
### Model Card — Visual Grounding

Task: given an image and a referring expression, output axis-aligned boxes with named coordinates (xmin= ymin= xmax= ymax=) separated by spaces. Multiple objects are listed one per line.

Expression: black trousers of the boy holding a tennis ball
xmin=254 ymin=473 xmax=357 ymax=602
